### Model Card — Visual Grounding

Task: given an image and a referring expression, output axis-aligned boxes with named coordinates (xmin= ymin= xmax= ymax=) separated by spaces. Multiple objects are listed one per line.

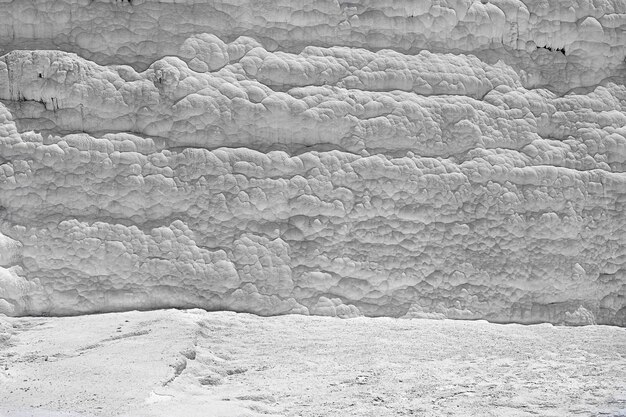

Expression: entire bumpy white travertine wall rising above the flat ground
xmin=0 ymin=0 xmax=626 ymax=326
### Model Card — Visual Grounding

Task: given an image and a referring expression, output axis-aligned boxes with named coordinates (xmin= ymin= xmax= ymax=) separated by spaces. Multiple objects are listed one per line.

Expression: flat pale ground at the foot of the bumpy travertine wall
xmin=0 ymin=310 xmax=626 ymax=417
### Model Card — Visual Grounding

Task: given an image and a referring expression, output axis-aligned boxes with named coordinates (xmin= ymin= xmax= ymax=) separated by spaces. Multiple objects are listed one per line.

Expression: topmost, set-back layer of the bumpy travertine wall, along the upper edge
xmin=0 ymin=0 xmax=626 ymax=92
